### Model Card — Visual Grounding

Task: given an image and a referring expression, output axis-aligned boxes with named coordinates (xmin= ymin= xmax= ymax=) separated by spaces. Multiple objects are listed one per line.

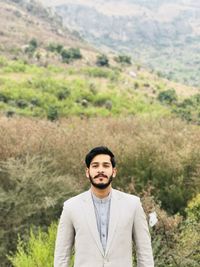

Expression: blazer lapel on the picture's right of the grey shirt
xmin=105 ymin=189 xmax=119 ymax=254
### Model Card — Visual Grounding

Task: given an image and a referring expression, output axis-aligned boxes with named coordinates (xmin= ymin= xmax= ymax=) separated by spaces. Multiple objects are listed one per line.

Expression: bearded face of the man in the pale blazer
xmin=86 ymin=154 xmax=116 ymax=189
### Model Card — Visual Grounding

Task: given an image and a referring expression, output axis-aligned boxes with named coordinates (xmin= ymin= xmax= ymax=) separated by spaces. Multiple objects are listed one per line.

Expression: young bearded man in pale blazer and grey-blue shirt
xmin=54 ymin=147 xmax=154 ymax=267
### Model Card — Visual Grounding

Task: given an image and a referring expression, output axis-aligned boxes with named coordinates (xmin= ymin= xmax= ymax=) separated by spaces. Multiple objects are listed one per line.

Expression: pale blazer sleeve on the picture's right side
xmin=133 ymin=198 xmax=154 ymax=267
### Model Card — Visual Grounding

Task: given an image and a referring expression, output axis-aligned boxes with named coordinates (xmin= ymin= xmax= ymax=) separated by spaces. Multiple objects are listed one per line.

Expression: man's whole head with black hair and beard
xmin=85 ymin=146 xmax=116 ymax=189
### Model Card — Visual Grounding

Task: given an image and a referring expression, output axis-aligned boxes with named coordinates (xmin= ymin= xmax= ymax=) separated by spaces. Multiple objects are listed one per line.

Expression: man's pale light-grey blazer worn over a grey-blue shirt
xmin=54 ymin=189 xmax=154 ymax=267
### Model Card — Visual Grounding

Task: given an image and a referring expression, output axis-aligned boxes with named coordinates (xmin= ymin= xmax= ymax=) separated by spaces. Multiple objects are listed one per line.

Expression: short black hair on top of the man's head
xmin=85 ymin=146 xmax=116 ymax=168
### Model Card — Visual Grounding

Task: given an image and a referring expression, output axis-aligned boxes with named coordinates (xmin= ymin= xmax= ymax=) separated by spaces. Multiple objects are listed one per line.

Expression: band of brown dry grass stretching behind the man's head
xmin=0 ymin=117 xmax=200 ymax=187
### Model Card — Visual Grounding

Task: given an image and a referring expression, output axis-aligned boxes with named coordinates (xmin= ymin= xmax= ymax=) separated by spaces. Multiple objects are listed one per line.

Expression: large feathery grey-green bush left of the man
xmin=0 ymin=154 xmax=76 ymax=267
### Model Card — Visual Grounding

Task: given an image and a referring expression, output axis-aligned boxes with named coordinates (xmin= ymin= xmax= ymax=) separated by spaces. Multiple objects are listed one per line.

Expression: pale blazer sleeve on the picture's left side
xmin=54 ymin=202 xmax=75 ymax=267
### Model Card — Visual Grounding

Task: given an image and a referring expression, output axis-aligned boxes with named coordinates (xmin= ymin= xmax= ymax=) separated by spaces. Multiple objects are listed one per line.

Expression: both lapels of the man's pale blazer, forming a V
xmin=83 ymin=189 xmax=119 ymax=255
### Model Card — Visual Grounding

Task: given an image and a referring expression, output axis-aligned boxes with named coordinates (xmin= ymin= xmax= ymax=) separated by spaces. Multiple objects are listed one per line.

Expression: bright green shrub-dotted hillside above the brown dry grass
xmin=0 ymin=54 xmax=200 ymax=123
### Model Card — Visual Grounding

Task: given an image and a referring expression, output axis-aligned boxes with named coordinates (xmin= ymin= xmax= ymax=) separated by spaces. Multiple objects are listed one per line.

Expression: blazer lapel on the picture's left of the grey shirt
xmin=83 ymin=191 xmax=104 ymax=255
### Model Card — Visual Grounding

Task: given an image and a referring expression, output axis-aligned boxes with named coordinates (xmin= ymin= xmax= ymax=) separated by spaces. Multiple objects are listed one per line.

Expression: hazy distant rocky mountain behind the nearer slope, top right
xmin=40 ymin=0 xmax=200 ymax=86
